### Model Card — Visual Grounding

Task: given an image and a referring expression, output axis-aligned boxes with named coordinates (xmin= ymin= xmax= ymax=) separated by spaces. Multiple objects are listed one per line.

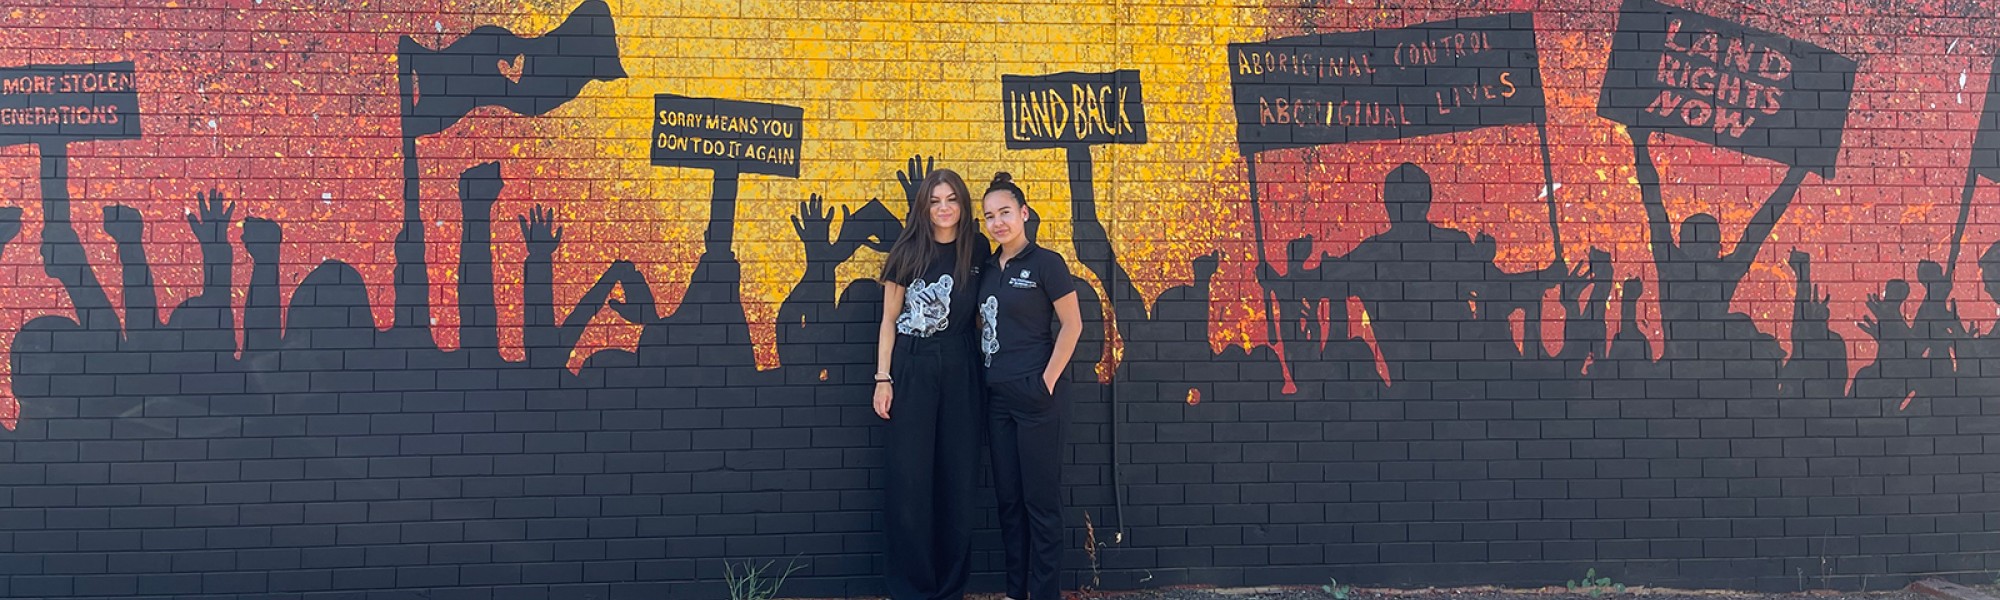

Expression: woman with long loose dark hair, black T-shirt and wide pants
xmin=874 ymin=168 xmax=990 ymax=600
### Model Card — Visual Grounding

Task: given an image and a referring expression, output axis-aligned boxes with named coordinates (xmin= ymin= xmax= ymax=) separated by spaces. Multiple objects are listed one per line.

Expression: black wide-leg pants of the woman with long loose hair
xmin=884 ymin=336 xmax=986 ymax=600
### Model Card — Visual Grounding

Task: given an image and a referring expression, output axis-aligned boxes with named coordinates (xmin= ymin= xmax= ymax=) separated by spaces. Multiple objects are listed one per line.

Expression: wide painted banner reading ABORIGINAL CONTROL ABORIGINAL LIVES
xmin=1228 ymin=12 xmax=1544 ymax=152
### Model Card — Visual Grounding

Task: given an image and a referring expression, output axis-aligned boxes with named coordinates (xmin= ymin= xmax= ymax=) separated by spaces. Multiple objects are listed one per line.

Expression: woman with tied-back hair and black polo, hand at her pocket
xmin=978 ymin=172 xmax=1084 ymax=600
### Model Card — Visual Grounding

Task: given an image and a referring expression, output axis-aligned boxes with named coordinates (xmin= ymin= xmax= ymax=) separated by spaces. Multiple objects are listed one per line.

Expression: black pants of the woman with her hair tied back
xmin=986 ymin=374 xmax=1066 ymax=600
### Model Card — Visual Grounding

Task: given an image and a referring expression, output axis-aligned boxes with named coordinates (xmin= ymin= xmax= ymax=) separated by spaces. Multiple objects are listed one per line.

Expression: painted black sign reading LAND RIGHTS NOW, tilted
xmin=1598 ymin=0 xmax=1854 ymax=178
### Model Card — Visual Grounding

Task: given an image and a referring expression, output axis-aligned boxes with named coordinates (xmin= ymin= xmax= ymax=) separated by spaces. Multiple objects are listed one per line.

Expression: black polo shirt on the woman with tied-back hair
xmin=980 ymin=242 xmax=1076 ymax=382
